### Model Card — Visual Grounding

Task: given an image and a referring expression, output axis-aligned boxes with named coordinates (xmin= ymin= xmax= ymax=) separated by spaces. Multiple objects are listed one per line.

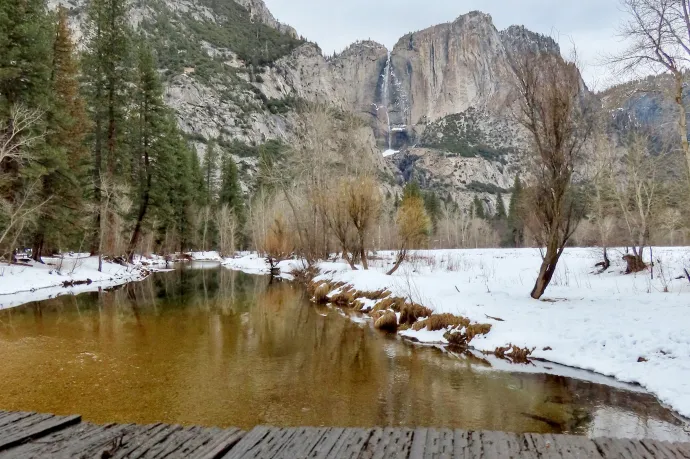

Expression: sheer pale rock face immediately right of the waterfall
xmin=391 ymin=12 xmax=510 ymax=126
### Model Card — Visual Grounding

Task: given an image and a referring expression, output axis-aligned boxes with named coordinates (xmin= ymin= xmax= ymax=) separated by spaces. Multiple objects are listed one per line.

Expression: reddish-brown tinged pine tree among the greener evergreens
xmin=32 ymin=7 xmax=89 ymax=261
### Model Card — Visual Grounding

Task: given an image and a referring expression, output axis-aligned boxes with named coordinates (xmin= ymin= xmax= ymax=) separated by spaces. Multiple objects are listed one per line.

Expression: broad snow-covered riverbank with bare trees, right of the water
xmin=224 ymin=248 xmax=690 ymax=416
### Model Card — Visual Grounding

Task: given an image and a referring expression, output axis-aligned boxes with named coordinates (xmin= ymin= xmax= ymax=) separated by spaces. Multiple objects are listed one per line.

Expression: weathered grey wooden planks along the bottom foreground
xmin=0 ymin=411 xmax=690 ymax=459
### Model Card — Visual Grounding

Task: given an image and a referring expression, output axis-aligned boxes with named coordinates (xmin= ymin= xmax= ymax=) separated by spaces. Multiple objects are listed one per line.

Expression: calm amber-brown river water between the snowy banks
xmin=0 ymin=265 xmax=688 ymax=439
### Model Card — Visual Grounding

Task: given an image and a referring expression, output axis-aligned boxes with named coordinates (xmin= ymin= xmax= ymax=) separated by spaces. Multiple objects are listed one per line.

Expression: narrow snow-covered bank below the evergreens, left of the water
xmin=0 ymin=254 xmax=148 ymax=309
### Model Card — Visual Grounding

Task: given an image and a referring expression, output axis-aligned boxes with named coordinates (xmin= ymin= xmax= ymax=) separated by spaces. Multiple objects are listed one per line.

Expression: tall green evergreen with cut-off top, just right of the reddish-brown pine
xmin=83 ymin=0 xmax=132 ymax=253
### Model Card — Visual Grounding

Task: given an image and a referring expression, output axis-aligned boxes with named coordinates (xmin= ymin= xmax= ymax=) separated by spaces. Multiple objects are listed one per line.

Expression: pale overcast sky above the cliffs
xmin=264 ymin=0 xmax=623 ymax=89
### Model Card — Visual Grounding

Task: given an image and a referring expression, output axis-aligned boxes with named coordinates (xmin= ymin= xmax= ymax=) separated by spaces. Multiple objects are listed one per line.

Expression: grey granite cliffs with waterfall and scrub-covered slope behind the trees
xmin=49 ymin=0 xmax=592 ymax=208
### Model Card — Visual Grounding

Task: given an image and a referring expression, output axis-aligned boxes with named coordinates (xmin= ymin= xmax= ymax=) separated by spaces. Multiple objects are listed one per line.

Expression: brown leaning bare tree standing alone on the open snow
xmin=511 ymin=48 xmax=592 ymax=299
